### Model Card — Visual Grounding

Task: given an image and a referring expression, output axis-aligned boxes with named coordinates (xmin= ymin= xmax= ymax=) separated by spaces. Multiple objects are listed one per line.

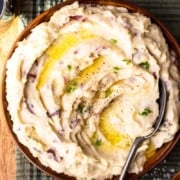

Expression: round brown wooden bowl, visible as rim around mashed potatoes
xmin=0 ymin=0 xmax=180 ymax=180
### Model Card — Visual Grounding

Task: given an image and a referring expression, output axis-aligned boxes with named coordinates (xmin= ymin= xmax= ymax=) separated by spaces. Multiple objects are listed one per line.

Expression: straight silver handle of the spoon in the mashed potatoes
xmin=119 ymin=136 xmax=145 ymax=180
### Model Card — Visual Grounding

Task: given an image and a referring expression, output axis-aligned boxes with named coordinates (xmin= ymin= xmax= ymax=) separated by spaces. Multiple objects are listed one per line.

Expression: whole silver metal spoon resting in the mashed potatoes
xmin=119 ymin=80 xmax=167 ymax=180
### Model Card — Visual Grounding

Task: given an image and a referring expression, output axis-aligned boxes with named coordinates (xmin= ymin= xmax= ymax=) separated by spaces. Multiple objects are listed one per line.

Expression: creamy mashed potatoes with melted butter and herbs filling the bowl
xmin=6 ymin=3 xmax=180 ymax=179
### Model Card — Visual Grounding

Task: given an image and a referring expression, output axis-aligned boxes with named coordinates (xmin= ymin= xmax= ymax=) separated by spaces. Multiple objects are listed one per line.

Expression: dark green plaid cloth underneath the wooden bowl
xmin=16 ymin=0 xmax=180 ymax=180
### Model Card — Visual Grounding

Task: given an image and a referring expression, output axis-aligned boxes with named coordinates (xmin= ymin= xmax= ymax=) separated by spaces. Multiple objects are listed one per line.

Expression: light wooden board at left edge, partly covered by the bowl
xmin=0 ymin=17 xmax=18 ymax=180
